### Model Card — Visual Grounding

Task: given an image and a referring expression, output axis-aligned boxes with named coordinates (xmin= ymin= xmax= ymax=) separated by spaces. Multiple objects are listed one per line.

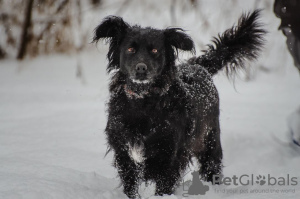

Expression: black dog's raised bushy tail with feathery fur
xmin=188 ymin=10 xmax=267 ymax=76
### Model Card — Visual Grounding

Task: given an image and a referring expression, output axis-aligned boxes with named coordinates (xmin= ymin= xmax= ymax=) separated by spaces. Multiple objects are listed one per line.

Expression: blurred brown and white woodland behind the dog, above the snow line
xmin=0 ymin=0 xmax=289 ymax=75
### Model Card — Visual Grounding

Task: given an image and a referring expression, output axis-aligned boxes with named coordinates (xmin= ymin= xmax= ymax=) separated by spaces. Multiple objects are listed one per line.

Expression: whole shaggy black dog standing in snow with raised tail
xmin=93 ymin=11 xmax=265 ymax=198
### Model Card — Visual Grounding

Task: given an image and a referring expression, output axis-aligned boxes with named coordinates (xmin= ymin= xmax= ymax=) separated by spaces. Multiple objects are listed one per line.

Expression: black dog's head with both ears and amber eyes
xmin=93 ymin=16 xmax=194 ymax=88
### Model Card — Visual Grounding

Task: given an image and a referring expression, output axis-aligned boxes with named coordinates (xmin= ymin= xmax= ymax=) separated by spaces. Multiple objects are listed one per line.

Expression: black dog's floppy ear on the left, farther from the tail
xmin=92 ymin=16 xmax=129 ymax=42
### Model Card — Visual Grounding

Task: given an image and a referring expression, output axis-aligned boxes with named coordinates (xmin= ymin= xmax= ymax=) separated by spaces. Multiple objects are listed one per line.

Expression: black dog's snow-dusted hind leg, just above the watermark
xmin=197 ymin=120 xmax=223 ymax=182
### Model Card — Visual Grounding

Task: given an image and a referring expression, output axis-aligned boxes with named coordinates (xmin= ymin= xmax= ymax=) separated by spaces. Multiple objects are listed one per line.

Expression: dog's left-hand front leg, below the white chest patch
xmin=115 ymin=150 xmax=140 ymax=199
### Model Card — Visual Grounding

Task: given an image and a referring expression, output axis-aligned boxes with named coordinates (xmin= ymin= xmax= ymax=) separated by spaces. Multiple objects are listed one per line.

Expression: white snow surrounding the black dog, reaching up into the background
xmin=0 ymin=0 xmax=300 ymax=199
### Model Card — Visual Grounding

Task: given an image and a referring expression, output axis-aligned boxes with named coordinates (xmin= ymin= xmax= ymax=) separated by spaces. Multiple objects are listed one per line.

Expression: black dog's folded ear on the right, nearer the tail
xmin=164 ymin=28 xmax=195 ymax=51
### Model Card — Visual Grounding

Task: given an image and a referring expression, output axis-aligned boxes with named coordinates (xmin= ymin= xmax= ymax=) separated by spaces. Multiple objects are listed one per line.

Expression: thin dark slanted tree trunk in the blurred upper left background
xmin=17 ymin=0 xmax=33 ymax=60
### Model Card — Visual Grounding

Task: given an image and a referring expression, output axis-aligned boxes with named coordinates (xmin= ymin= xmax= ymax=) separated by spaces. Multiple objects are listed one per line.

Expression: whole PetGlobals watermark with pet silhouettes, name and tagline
xmin=182 ymin=171 xmax=299 ymax=197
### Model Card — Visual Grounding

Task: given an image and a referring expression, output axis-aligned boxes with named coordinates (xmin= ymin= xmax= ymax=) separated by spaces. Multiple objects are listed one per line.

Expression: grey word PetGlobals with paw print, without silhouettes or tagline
xmin=212 ymin=174 xmax=298 ymax=186
